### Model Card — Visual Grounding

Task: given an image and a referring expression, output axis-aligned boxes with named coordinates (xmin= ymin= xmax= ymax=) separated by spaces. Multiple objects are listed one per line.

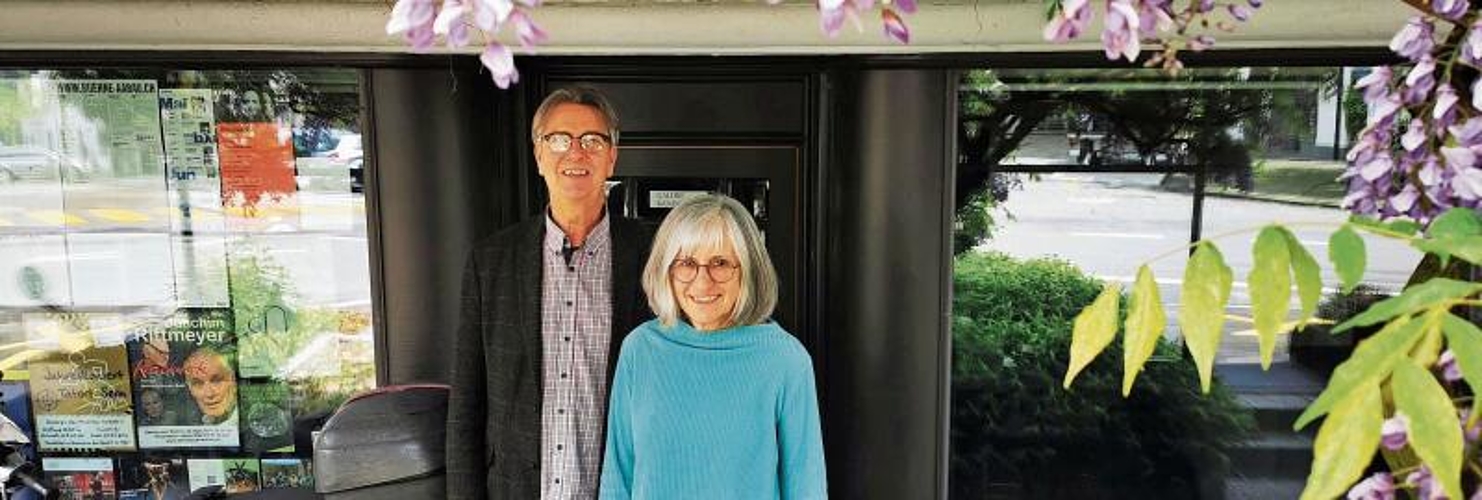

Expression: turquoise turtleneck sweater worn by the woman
xmin=600 ymin=319 xmax=828 ymax=500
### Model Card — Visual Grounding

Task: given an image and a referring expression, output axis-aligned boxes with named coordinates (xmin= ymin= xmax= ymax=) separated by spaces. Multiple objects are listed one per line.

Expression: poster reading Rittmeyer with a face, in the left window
xmin=129 ymin=309 xmax=240 ymax=450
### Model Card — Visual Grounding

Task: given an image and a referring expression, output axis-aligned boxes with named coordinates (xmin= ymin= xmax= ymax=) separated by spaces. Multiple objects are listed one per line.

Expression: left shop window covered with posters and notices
xmin=0 ymin=68 xmax=375 ymax=499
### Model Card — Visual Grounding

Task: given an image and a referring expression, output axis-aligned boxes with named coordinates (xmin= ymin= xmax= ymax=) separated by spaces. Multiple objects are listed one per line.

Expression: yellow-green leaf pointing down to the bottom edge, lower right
xmin=1301 ymin=384 xmax=1384 ymax=500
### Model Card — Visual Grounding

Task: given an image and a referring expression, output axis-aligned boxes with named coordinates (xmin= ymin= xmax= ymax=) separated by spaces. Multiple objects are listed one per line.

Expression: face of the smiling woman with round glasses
xmin=668 ymin=237 xmax=741 ymax=331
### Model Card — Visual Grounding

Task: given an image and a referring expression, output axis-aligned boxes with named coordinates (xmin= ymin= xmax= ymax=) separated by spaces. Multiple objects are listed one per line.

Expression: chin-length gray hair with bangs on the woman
xmin=643 ymin=194 xmax=777 ymax=326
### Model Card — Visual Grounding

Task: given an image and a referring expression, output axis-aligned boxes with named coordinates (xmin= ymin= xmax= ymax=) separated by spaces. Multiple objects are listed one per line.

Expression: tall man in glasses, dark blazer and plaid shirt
xmin=446 ymin=88 xmax=652 ymax=500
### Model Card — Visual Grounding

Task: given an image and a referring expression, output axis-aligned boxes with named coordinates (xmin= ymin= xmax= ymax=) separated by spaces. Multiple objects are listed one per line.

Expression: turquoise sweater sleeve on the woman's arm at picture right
xmin=777 ymin=346 xmax=828 ymax=500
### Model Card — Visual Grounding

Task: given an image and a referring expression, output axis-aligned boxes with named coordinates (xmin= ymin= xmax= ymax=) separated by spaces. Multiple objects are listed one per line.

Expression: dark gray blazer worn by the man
xmin=446 ymin=214 xmax=654 ymax=500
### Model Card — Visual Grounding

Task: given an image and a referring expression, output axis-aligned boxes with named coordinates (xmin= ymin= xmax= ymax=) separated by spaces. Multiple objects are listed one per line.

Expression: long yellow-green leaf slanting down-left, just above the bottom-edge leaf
xmin=1292 ymin=316 xmax=1424 ymax=430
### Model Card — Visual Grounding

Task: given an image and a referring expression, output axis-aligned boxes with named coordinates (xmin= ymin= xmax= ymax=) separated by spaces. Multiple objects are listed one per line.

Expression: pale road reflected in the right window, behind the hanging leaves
xmin=980 ymin=174 xmax=1421 ymax=362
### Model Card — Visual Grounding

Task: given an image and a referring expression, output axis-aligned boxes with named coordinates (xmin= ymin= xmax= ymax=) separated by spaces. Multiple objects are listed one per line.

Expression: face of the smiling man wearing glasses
xmin=535 ymin=102 xmax=618 ymax=205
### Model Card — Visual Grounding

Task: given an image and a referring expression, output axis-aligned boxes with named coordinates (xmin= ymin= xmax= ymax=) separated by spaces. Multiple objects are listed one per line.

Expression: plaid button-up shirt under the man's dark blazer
xmin=541 ymin=210 xmax=612 ymax=500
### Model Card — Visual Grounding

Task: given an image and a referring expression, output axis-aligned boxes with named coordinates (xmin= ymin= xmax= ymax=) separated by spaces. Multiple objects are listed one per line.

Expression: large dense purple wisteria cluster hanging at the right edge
xmin=1343 ymin=0 xmax=1482 ymax=223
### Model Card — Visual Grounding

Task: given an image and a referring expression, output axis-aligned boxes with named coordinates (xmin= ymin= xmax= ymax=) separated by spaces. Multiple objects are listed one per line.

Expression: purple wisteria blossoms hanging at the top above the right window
xmin=1045 ymin=0 xmax=1264 ymax=73
